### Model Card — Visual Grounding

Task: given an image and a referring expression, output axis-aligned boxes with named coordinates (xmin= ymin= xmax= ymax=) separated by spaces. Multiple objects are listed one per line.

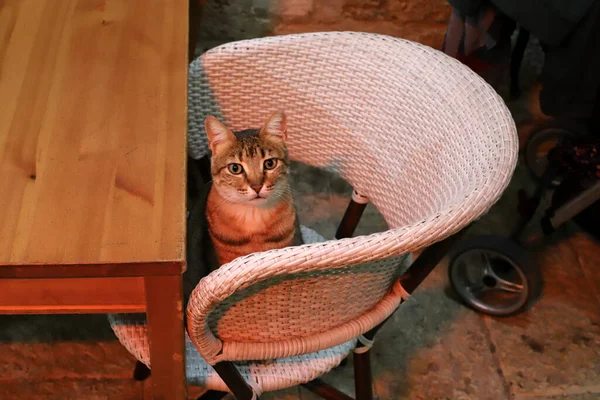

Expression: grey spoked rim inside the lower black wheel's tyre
xmin=451 ymin=249 xmax=529 ymax=315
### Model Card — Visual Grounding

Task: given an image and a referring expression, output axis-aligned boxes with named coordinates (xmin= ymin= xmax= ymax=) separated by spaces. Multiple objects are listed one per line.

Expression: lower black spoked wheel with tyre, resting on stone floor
xmin=448 ymin=236 xmax=542 ymax=317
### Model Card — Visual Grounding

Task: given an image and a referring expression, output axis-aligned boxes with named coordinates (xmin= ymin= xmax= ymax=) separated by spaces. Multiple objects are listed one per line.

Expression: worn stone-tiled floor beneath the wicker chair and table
xmin=0 ymin=44 xmax=600 ymax=400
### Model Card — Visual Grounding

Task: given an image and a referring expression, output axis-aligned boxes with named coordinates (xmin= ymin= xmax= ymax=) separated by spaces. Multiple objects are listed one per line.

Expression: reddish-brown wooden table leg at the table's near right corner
xmin=144 ymin=275 xmax=187 ymax=400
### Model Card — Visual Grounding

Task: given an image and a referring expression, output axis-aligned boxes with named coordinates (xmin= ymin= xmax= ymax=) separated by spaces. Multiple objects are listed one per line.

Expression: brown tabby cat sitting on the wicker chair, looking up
xmin=184 ymin=111 xmax=302 ymax=303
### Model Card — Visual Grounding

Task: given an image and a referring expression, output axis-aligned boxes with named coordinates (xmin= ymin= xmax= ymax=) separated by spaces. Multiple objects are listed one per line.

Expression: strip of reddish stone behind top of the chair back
xmin=197 ymin=0 xmax=450 ymax=53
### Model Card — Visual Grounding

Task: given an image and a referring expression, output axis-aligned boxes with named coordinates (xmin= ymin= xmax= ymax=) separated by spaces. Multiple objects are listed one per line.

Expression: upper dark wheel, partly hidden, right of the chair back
xmin=525 ymin=119 xmax=589 ymax=186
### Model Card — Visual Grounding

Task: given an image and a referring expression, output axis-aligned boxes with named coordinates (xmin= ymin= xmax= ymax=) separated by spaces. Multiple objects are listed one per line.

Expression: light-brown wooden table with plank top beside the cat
xmin=0 ymin=0 xmax=188 ymax=399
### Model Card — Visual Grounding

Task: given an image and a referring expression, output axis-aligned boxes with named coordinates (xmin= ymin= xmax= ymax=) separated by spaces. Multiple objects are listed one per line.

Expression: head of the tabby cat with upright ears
xmin=204 ymin=111 xmax=289 ymax=206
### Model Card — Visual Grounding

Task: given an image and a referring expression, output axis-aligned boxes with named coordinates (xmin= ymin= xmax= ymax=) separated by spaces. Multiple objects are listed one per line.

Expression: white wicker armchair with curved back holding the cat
xmin=112 ymin=32 xmax=518 ymax=399
